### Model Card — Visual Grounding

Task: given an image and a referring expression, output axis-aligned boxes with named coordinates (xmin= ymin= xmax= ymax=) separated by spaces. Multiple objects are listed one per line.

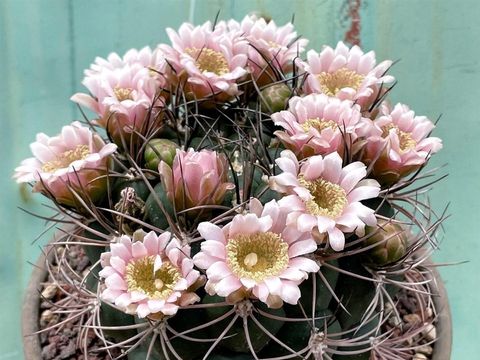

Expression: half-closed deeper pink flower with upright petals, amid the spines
xmin=158 ymin=149 xmax=234 ymax=211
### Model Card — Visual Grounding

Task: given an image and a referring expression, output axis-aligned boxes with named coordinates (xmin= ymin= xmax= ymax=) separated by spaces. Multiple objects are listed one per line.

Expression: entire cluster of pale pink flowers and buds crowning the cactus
xmin=14 ymin=16 xmax=442 ymax=358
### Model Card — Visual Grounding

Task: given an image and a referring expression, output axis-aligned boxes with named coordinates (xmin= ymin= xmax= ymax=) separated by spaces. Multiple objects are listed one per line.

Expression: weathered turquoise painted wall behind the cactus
xmin=0 ymin=0 xmax=480 ymax=360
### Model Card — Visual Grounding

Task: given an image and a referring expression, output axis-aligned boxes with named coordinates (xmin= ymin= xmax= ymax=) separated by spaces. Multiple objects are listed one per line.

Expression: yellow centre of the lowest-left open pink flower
xmin=125 ymin=256 xmax=181 ymax=300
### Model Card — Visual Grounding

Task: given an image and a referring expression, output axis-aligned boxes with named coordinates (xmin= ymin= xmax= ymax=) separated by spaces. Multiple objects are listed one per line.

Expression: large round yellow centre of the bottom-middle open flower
xmin=226 ymin=232 xmax=289 ymax=282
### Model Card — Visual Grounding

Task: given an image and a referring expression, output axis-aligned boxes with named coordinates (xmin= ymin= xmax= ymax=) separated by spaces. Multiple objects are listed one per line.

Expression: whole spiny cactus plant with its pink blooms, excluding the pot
xmin=15 ymin=16 xmax=445 ymax=360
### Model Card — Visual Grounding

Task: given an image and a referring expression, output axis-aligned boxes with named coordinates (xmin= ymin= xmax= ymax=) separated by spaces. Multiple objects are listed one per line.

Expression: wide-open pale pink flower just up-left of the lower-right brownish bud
xmin=270 ymin=150 xmax=380 ymax=251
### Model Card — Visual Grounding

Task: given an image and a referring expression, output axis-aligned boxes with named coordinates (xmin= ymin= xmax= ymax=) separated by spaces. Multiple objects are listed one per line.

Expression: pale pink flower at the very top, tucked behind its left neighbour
xmin=228 ymin=15 xmax=308 ymax=85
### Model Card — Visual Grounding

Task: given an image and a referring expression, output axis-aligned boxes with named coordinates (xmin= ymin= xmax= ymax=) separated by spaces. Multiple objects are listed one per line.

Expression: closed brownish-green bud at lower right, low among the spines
xmin=365 ymin=221 xmax=408 ymax=266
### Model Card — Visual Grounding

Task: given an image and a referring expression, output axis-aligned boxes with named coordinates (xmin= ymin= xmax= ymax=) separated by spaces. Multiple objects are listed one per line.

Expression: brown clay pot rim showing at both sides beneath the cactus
xmin=22 ymin=252 xmax=452 ymax=360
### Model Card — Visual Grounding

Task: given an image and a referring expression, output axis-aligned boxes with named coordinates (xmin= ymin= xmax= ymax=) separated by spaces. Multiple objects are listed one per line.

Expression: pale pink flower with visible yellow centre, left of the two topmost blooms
xmin=160 ymin=22 xmax=248 ymax=101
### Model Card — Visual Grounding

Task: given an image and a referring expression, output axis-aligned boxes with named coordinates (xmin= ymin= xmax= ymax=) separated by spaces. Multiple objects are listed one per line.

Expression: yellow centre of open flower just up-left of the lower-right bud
xmin=299 ymin=178 xmax=348 ymax=219
